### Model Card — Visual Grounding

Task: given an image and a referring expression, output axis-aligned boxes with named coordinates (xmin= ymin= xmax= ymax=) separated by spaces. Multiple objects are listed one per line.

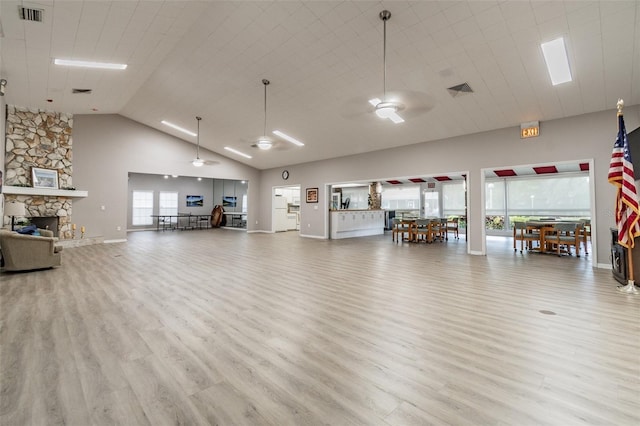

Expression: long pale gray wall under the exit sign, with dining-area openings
xmin=259 ymin=106 xmax=640 ymax=265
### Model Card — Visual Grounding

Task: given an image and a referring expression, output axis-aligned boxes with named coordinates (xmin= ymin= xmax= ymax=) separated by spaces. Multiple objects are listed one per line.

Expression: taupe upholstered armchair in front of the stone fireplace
xmin=0 ymin=229 xmax=62 ymax=271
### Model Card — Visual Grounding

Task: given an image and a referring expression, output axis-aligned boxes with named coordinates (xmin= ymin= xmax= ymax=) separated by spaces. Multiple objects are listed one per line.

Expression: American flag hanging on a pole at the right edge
xmin=609 ymin=114 xmax=640 ymax=248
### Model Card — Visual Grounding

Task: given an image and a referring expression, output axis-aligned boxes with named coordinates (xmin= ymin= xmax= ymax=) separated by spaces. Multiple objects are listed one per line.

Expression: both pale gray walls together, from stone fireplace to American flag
xmin=73 ymin=106 xmax=640 ymax=265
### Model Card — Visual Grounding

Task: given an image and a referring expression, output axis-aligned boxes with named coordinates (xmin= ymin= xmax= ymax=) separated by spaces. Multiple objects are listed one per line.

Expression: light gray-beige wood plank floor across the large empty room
xmin=0 ymin=229 xmax=640 ymax=426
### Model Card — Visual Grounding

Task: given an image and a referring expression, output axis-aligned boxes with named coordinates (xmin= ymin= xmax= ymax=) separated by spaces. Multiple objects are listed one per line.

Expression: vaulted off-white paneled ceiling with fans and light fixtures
xmin=0 ymin=0 xmax=640 ymax=169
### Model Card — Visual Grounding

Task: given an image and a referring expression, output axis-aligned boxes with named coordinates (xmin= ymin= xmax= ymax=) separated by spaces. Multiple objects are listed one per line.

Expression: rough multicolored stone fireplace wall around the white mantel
xmin=4 ymin=105 xmax=73 ymax=239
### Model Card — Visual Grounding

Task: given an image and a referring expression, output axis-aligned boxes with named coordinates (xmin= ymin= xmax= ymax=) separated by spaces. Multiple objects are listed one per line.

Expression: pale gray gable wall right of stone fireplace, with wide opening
xmin=73 ymin=115 xmax=262 ymax=241
